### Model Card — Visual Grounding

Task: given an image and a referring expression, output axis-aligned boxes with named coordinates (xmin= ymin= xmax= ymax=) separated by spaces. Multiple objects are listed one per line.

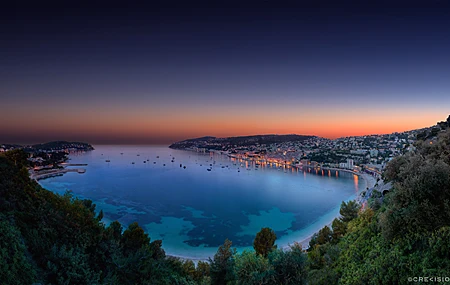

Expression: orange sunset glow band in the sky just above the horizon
xmin=0 ymin=102 xmax=448 ymax=143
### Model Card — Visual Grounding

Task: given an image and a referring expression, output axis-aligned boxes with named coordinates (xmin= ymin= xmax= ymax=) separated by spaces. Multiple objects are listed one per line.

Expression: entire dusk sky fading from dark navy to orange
xmin=0 ymin=0 xmax=450 ymax=144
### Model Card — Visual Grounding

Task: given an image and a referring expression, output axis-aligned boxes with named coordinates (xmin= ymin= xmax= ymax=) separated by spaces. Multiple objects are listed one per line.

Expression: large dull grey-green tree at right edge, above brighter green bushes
xmin=380 ymin=131 xmax=450 ymax=239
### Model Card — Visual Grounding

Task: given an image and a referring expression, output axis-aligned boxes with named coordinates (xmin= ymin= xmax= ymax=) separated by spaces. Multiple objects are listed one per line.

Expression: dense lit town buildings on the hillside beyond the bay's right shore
xmin=181 ymin=127 xmax=428 ymax=174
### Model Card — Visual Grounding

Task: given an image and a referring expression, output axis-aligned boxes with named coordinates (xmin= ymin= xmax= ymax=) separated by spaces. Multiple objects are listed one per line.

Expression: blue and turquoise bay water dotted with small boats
xmin=40 ymin=146 xmax=365 ymax=258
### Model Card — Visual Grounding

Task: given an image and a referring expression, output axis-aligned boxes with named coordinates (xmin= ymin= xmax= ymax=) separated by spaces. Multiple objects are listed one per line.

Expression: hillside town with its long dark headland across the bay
xmin=170 ymin=122 xmax=447 ymax=178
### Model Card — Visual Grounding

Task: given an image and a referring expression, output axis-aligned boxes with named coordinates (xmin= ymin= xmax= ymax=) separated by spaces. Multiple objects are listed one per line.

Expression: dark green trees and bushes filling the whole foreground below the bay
xmin=0 ymin=127 xmax=450 ymax=284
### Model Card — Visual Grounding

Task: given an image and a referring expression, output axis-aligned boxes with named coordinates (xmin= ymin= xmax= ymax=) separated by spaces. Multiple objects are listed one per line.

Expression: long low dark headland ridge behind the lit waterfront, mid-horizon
xmin=169 ymin=134 xmax=316 ymax=149
